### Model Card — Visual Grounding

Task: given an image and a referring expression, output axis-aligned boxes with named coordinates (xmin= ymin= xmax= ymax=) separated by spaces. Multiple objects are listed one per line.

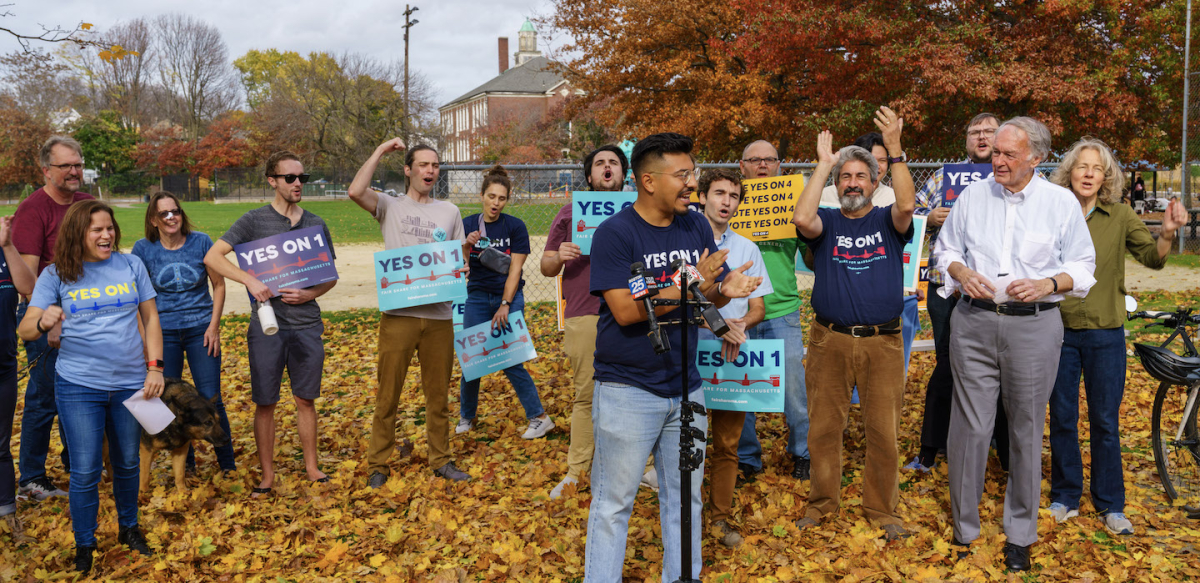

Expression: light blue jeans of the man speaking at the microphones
xmin=583 ymin=380 xmax=708 ymax=583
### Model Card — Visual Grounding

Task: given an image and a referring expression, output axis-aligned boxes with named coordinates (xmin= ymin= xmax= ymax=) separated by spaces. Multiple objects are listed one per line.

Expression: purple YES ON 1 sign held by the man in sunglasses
xmin=233 ymin=227 xmax=337 ymax=295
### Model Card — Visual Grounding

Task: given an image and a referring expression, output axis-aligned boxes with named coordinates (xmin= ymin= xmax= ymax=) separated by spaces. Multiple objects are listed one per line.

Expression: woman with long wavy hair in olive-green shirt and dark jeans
xmin=1049 ymin=138 xmax=1187 ymax=535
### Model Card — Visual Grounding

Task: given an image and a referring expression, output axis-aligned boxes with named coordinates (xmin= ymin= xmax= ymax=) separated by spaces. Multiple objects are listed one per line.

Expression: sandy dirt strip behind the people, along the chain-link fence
xmin=226 ymin=241 xmax=1200 ymax=313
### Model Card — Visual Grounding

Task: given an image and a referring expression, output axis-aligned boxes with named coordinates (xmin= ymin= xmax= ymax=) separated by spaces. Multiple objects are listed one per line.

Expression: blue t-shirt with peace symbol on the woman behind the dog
xmin=133 ymin=233 xmax=212 ymax=330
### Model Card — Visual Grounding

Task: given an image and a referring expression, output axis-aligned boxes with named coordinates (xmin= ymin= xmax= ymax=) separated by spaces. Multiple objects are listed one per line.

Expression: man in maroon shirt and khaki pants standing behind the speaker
xmin=541 ymin=145 xmax=629 ymax=498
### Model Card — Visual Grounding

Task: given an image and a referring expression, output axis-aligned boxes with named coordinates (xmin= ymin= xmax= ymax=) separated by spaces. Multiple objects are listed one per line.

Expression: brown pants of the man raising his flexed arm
xmin=367 ymin=314 xmax=455 ymax=475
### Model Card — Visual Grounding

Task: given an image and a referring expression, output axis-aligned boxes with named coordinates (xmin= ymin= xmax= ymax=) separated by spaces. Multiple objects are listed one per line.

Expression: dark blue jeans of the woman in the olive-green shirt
xmin=1050 ymin=327 xmax=1126 ymax=516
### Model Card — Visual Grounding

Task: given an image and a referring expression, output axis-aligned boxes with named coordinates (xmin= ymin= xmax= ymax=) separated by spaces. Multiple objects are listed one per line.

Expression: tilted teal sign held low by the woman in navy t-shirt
xmin=454 ymin=312 xmax=538 ymax=380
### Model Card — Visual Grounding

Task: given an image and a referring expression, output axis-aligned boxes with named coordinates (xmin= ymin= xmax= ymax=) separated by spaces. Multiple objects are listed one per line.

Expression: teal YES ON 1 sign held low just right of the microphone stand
xmin=696 ymin=339 xmax=787 ymax=413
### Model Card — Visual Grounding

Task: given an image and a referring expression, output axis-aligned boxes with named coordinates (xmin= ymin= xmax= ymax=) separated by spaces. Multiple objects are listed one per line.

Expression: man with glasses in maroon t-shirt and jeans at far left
xmin=12 ymin=136 xmax=92 ymax=500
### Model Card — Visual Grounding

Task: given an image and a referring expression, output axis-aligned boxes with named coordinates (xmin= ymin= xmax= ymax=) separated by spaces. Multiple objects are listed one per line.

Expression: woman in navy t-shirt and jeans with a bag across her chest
xmin=455 ymin=164 xmax=554 ymax=439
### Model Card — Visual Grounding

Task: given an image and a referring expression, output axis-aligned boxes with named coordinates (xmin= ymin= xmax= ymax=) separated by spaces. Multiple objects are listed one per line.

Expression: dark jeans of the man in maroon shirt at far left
xmin=17 ymin=302 xmax=71 ymax=486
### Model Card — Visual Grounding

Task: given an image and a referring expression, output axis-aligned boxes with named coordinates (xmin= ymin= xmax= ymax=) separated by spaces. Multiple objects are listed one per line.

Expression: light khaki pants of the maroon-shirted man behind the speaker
xmin=563 ymin=315 xmax=600 ymax=480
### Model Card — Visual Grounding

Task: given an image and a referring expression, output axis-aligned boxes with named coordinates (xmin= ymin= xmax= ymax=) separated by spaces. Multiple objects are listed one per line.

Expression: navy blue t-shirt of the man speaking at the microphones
xmin=592 ymin=206 xmax=728 ymax=398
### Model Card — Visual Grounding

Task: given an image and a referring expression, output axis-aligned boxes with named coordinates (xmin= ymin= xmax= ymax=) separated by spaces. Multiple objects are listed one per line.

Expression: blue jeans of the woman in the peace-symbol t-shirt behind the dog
xmin=162 ymin=324 xmax=236 ymax=470
